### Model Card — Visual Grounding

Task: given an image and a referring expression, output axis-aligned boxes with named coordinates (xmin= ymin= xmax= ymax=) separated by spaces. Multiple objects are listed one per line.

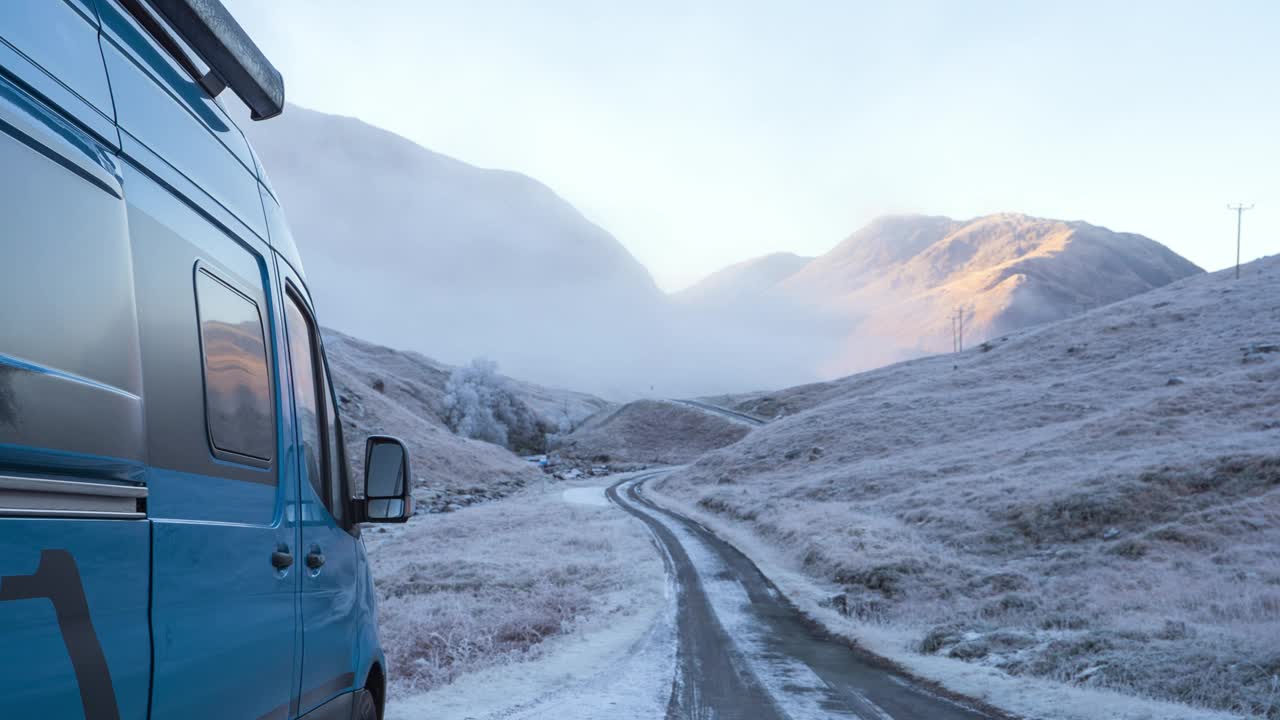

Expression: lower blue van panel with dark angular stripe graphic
xmin=0 ymin=518 xmax=151 ymax=720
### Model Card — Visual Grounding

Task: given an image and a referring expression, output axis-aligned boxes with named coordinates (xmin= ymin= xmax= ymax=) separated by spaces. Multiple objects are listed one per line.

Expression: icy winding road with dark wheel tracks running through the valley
xmin=607 ymin=471 xmax=997 ymax=720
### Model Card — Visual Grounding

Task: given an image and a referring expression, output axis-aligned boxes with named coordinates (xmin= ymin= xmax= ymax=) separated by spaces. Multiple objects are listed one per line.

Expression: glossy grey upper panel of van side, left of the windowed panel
xmin=0 ymin=65 xmax=145 ymax=471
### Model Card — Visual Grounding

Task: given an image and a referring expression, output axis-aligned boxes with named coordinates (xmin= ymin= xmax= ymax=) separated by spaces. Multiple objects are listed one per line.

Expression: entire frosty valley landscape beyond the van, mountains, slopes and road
xmin=255 ymin=103 xmax=1280 ymax=720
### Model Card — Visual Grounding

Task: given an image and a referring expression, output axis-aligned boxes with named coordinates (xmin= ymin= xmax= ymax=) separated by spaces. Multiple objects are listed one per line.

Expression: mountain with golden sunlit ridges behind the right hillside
xmin=684 ymin=213 xmax=1201 ymax=377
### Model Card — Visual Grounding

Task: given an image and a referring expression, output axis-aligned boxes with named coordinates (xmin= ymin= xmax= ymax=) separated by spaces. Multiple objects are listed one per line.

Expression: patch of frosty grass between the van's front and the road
xmin=366 ymin=486 xmax=663 ymax=694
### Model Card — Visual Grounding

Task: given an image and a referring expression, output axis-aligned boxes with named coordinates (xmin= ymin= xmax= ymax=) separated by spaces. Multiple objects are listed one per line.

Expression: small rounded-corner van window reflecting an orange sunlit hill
xmin=196 ymin=269 xmax=275 ymax=461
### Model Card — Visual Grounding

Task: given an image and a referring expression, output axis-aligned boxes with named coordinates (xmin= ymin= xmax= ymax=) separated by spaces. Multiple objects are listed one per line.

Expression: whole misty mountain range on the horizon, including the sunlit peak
xmin=247 ymin=106 xmax=1199 ymax=401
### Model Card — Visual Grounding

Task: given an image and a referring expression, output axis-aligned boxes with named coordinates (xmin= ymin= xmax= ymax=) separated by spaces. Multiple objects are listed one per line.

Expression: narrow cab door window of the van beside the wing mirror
xmin=284 ymin=291 xmax=346 ymax=524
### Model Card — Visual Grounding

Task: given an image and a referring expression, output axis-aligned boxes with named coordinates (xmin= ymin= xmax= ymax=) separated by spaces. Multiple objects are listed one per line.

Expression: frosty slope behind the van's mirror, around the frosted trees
xmin=324 ymin=329 xmax=607 ymax=510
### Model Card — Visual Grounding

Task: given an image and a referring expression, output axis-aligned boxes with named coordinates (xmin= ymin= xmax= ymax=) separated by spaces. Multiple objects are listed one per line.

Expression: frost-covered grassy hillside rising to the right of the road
xmin=658 ymin=254 xmax=1280 ymax=717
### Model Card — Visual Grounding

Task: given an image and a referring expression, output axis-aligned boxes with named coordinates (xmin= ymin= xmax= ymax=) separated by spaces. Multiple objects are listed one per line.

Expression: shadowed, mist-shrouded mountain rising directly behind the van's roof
xmin=246 ymin=105 xmax=666 ymax=388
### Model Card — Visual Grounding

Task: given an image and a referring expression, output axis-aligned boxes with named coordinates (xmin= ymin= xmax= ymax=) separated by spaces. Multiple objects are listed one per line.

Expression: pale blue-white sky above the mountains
xmin=224 ymin=0 xmax=1280 ymax=291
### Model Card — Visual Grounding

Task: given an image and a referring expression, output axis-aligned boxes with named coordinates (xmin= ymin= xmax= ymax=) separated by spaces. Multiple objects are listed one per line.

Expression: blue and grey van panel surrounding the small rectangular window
xmin=124 ymin=162 xmax=301 ymax=720
